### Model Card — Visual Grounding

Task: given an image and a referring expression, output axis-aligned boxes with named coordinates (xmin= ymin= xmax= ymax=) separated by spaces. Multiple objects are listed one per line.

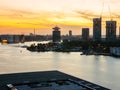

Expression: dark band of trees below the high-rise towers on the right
xmin=63 ymin=40 xmax=120 ymax=53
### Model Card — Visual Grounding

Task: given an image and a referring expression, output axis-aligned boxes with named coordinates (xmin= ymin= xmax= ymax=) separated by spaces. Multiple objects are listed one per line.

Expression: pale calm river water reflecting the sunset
xmin=0 ymin=42 xmax=120 ymax=90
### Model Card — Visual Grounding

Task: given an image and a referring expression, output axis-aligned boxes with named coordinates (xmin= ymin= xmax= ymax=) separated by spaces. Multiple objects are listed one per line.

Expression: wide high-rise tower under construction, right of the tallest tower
xmin=106 ymin=21 xmax=116 ymax=40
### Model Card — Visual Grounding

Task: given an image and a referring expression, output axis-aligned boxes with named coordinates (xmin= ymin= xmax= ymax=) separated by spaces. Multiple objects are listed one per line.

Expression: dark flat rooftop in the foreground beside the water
xmin=0 ymin=71 xmax=110 ymax=90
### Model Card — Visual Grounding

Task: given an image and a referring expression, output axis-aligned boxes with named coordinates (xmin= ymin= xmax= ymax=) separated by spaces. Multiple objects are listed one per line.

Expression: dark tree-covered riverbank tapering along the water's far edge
xmin=26 ymin=43 xmax=120 ymax=58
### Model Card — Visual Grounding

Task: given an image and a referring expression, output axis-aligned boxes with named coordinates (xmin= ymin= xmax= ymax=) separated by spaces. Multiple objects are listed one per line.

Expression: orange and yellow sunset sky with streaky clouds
xmin=0 ymin=0 xmax=120 ymax=35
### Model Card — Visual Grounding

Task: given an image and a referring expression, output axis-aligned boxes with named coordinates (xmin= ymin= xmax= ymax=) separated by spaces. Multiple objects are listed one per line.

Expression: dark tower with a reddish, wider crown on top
xmin=52 ymin=26 xmax=61 ymax=42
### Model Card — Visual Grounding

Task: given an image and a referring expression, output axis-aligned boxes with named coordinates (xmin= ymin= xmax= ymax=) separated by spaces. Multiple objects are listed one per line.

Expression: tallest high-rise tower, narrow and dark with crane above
xmin=93 ymin=18 xmax=102 ymax=40
